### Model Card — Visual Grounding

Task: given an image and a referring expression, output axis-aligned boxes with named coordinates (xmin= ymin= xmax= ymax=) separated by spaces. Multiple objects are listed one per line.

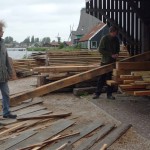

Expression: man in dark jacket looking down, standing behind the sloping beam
xmin=93 ymin=26 xmax=120 ymax=99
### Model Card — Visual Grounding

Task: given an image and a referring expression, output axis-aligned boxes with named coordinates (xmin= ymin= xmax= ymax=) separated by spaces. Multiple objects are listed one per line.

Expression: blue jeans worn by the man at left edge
xmin=0 ymin=82 xmax=10 ymax=116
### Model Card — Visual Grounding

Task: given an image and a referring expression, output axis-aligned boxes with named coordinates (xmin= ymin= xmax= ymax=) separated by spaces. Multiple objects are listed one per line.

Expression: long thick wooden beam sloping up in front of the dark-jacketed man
xmin=10 ymin=52 xmax=150 ymax=104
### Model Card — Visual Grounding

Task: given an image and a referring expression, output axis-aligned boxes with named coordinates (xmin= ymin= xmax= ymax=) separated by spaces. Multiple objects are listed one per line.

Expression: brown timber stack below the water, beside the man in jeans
xmin=13 ymin=59 xmax=39 ymax=78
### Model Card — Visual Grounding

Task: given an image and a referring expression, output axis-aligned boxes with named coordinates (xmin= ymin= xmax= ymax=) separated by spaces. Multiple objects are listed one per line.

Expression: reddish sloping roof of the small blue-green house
xmin=79 ymin=22 xmax=106 ymax=42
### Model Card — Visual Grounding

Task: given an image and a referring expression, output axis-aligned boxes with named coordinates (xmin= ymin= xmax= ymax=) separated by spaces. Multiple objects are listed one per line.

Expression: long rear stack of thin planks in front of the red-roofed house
xmin=46 ymin=50 xmax=129 ymax=66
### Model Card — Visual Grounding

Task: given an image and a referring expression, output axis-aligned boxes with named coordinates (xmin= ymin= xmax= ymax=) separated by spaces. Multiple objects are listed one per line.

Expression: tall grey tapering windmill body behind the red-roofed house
xmin=71 ymin=8 xmax=100 ymax=45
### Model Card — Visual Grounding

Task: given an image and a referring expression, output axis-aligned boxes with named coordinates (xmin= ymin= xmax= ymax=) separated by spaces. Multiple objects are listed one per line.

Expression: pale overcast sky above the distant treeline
xmin=0 ymin=0 xmax=85 ymax=42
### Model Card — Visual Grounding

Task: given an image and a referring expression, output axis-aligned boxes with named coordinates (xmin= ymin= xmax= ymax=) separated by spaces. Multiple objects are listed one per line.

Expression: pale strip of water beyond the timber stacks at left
xmin=7 ymin=48 xmax=33 ymax=59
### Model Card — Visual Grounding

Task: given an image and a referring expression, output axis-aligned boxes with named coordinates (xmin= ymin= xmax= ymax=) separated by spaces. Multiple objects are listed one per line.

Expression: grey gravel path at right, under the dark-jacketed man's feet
xmin=88 ymin=94 xmax=150 ymax=139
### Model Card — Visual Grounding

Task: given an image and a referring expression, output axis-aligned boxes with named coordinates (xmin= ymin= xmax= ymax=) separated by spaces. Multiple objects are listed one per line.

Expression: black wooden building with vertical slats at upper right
xmin=86 ymin=0 xmax=150 ymax=55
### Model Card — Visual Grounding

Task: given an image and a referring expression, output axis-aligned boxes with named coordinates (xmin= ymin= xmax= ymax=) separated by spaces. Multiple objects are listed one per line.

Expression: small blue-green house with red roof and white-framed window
xmin=79 ymin=23 xmax=109 ymax=49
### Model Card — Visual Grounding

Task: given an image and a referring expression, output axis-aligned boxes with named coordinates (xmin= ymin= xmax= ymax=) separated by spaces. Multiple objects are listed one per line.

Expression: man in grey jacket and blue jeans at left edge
xmin=0 ymin=21 xmax=17 ymax=119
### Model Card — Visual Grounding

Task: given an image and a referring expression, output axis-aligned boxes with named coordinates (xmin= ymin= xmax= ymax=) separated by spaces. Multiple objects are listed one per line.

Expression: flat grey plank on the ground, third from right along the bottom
xmin=45 ymin=120 xmax=103 ymax=150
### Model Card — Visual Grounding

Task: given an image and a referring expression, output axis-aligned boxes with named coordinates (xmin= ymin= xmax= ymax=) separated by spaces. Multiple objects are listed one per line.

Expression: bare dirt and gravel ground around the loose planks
xmin=0 ymin=77 xmax=150 ymax=150
